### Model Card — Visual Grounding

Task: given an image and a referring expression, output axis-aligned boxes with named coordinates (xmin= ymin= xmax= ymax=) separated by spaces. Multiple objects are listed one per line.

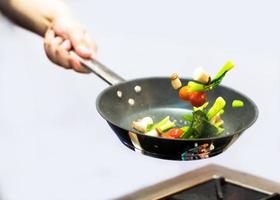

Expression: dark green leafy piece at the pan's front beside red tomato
xmin=191 ymin=110 xmax=218 ymax=138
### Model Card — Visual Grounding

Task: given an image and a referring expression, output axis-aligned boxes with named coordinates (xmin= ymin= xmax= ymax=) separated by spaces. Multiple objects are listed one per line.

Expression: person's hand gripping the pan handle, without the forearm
xmin=44 ymin=16 xmax=97 ymax=73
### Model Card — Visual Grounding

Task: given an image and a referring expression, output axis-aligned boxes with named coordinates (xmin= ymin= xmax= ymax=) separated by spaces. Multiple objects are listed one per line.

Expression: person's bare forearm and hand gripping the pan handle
xmin=0 ymin=0 xmax=96 ymax=73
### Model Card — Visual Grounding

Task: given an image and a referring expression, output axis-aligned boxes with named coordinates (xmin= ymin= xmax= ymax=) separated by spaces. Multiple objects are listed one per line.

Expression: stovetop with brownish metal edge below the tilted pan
xmin=119 ymin=165 xmax=280 ymax=200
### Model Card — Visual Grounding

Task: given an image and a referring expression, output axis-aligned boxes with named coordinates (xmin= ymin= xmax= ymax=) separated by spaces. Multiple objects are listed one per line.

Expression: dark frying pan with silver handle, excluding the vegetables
xmin=76 ymin=55 xmax=258 ymax=160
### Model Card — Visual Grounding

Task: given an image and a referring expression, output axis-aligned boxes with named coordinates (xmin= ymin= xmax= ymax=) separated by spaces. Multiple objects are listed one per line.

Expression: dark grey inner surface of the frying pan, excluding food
xmin=97 ymin=78 xmax=257 ymax=138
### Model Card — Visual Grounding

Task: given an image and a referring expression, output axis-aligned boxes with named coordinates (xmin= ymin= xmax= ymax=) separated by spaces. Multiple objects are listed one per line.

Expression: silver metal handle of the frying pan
xmin=70 ymin=51 xmax=125 ymax=85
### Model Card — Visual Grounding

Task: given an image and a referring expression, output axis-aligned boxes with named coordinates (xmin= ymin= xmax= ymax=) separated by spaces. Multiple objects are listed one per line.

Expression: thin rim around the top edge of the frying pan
xmin=95 ymin=76 xmax=259 ymax=142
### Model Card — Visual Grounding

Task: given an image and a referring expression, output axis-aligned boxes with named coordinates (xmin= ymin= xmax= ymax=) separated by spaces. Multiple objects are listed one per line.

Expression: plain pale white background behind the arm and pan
xmin=0 ymin=0 xmax=280 ymax=200
